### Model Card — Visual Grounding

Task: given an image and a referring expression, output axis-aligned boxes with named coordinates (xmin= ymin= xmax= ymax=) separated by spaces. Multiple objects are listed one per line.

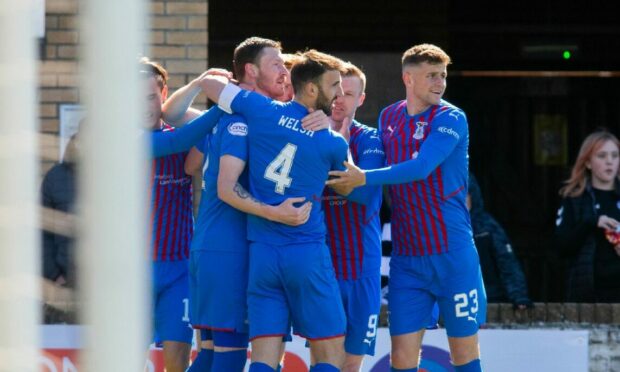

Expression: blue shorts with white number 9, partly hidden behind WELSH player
xmin=338 ymin=271 xmax=381 ymax=355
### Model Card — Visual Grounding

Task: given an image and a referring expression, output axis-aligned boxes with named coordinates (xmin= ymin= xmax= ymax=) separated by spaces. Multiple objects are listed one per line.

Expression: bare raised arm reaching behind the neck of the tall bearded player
xmin=162 ymin=69 xmax=231 ymax=127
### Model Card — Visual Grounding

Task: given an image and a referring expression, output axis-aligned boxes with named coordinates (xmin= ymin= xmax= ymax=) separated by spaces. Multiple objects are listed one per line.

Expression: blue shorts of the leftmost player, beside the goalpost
xmin=152 ymin=260 xmax=193 ymax=344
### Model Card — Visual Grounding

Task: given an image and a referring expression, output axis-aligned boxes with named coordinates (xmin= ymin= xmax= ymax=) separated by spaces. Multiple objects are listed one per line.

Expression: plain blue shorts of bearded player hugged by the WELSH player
xmin=189 ymin=250 xmax=248 ymax=333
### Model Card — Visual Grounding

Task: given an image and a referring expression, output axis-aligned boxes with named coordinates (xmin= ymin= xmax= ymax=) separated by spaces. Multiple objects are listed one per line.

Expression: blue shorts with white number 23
xmin=388 ymin=247 xmax=487 ymax=337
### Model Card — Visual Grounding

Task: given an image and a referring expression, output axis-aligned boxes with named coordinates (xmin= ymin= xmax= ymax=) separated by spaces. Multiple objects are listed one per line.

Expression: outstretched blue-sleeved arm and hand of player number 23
xmin=327 ymin=114 xmax=464 ymax=187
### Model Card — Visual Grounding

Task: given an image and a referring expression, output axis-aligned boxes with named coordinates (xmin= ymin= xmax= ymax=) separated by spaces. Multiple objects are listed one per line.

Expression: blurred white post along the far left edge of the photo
xmin=0 ymin=0 xmax=40 ymax=371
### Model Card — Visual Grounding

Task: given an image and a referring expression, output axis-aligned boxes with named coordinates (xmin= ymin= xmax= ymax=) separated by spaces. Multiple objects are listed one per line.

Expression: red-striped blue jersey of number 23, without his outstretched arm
xmin=379 ymin=100 xmax=474 ymax=256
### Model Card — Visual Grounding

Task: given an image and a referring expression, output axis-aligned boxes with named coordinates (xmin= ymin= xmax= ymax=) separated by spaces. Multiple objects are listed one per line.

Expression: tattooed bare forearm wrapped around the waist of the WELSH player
xmin=217 ymin=155 xmax=312 ymax=226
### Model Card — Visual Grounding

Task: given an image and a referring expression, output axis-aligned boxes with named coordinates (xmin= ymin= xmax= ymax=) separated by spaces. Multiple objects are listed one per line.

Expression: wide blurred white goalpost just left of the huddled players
xmin=79 ymin=0 xmax=150 ymax=372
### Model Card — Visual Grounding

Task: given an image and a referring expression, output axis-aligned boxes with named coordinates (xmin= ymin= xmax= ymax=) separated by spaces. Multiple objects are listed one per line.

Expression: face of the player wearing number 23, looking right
xmin=403 ymin=62 xmax=448 ymax=114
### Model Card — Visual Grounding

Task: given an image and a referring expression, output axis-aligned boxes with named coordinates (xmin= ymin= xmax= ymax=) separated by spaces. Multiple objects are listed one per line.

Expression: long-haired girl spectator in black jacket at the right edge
xmin=556 ymin=131 xmax=620 ymax=302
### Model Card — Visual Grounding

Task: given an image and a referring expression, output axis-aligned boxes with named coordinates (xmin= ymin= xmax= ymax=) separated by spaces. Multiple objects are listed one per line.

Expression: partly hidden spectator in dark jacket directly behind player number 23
xmin=467 ymin=173 xmax=532 ymax=309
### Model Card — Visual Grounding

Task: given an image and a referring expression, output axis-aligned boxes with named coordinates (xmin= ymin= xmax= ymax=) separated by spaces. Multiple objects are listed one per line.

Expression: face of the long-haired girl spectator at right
xmin=586 ymin=140 xmax=620 ymax=190
